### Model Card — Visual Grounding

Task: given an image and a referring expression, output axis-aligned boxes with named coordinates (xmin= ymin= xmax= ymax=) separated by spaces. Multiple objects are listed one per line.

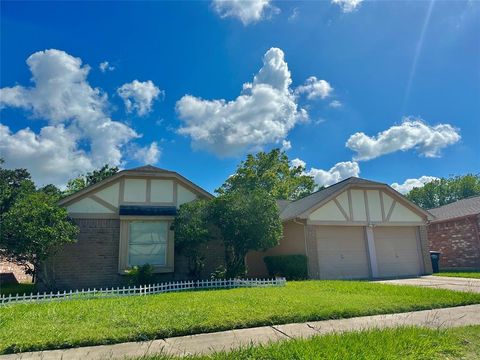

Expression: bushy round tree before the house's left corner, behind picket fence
xmin=0 ymin=192 xmax=78 ymax=285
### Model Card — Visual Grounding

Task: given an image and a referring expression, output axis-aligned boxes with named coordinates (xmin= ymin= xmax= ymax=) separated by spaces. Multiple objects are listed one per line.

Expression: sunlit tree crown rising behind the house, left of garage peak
xmin=216 ymin=149 xmax=315 ymax=200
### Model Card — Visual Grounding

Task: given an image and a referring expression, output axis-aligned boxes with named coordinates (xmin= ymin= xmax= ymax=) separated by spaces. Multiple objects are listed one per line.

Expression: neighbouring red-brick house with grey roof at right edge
xmin=428 ymin=196 xmax=480 ymax=269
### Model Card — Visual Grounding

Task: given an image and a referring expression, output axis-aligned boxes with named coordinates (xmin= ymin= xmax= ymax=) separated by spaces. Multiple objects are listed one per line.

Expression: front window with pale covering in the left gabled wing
xmin=128 ymin=221 xmax=168 ymax=266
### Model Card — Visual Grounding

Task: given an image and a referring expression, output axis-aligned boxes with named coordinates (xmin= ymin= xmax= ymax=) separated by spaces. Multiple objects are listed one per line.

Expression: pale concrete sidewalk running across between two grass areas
xmin=0 ymin=305 xmax=480 ymax=360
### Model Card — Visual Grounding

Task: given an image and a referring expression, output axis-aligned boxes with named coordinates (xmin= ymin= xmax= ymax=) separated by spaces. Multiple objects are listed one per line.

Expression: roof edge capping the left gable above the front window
xmin=58 ymin=165 xmax=213 ymax=205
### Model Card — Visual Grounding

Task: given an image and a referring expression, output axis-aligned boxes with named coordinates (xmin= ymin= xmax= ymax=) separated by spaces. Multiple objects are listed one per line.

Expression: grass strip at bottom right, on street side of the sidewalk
xmin=141 ymin=326 xmax=480 ymax=360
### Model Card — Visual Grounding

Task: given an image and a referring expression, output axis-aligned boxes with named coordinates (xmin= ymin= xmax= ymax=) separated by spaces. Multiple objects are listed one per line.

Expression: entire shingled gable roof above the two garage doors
xmin=280 ymin=177 xmax=433 ymax=221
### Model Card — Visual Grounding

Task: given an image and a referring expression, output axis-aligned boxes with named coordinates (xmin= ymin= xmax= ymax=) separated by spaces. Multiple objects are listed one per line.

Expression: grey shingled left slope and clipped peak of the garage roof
xmin=280 ymin=177 xmax=385 ymax=220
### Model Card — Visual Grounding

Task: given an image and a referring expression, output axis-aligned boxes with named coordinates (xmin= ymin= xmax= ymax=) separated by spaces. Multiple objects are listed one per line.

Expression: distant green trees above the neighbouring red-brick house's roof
xmin=406 ymin=174 xmax=480 ymax=209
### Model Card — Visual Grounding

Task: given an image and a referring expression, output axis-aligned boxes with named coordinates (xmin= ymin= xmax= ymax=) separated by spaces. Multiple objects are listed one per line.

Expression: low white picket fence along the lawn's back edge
xmin=0 ymin=278 xmax=287 ymax=305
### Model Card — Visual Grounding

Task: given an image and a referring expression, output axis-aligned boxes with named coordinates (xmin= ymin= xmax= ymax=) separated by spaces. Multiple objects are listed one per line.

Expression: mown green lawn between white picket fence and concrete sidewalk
xmin=0 ymin=281 xmax=480 ymax=353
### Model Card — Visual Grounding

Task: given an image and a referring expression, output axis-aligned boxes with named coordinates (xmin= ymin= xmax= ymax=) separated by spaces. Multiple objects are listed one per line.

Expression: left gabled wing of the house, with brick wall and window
xmin=39 ymin=166 xmax=223 ymax=289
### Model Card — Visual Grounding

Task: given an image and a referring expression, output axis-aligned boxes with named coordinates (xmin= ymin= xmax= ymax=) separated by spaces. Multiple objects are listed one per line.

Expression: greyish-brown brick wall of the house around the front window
xmin=38 ymin=219 xmax=223 ymax=290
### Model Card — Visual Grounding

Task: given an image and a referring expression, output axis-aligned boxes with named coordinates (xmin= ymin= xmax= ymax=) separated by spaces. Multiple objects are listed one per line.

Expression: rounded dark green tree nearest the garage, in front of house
xmin=210 ymin=189 xmax=283 ymax=277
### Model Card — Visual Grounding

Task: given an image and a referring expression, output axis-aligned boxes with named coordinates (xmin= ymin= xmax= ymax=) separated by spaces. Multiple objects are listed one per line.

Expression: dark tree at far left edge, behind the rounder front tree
xmin=0 ymin=158 xmax=35 ymax=215
